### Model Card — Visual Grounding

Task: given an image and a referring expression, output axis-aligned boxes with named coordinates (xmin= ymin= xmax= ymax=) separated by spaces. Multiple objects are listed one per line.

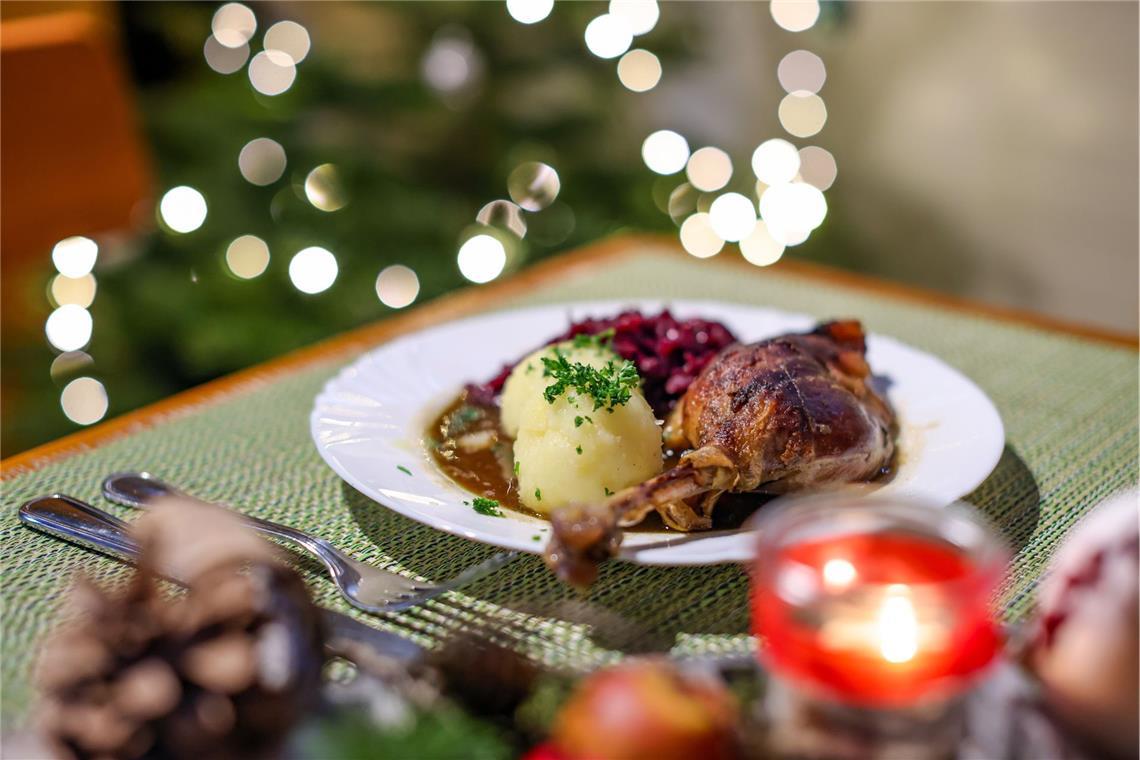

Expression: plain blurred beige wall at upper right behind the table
xmin=629 ymin=1 xmax=1140 ymax=332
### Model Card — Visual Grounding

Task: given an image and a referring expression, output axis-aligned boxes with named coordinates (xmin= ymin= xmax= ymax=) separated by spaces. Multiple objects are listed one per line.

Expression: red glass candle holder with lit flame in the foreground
xmin=752 ymin=493 xmax=1007 ymax=709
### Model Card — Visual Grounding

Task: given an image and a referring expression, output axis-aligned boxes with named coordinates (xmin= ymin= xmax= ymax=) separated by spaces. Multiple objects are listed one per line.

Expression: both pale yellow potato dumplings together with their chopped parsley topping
xmin=502 ymin=340 xmax=661 ymax=514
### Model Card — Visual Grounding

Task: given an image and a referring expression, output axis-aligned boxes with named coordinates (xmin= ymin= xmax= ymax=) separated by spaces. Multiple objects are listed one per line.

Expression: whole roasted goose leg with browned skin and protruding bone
xmin=545 ymin=321 xmax=895 ymax=585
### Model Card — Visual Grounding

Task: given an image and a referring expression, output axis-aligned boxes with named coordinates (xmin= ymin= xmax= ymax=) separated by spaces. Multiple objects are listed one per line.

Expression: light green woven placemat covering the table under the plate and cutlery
xmin=0 ymin=250 xmax=1138 ymax=726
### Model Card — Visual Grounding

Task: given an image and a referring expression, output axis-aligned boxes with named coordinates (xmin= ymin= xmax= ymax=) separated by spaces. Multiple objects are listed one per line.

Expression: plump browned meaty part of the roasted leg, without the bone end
xmin=681 ymin=321 xmax=894 ymax=492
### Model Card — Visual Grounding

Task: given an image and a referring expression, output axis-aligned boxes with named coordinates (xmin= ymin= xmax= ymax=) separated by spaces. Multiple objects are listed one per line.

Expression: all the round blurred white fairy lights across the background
xmin=44 ymin=0 xmax=837 ymax=425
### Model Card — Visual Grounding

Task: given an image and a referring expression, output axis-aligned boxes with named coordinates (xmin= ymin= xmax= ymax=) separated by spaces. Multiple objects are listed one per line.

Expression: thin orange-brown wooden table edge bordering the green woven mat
xmin=0 ymin=234 xmax=1140 ymax=480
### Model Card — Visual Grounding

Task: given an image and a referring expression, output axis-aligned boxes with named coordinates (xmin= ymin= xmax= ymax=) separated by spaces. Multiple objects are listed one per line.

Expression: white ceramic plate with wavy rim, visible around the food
xmin=310 ymin=301 xmax=1005 ymax=565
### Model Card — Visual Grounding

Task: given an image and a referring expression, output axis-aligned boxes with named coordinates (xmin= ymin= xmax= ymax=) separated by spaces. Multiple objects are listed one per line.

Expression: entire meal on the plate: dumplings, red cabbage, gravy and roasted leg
xmin=429 ymin=311 xmax=896 ymax=583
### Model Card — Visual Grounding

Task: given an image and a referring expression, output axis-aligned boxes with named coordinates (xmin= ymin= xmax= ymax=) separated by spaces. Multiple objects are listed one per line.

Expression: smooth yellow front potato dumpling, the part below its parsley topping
xmin=514 ymin=390 xmax=661 ymax=514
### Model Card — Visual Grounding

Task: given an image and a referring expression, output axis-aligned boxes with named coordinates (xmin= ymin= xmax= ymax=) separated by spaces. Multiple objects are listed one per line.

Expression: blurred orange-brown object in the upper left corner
xmin=0 ymin=3 xmax=152 ymax=279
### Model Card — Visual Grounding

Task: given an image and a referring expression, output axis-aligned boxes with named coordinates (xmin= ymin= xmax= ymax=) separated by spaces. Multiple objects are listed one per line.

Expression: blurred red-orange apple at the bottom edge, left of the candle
xmin=551 ymin=659 xmax=738 ymax=760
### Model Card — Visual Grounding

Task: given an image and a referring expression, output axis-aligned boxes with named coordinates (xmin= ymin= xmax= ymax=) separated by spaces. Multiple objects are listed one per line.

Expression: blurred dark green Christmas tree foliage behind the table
xmin=5 ymin=2 xmax=676 ymax=452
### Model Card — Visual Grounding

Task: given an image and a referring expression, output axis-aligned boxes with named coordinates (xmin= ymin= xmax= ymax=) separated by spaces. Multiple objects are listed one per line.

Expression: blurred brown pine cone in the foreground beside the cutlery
xmin=39 ymin=505 xmax=324 ymax=760
